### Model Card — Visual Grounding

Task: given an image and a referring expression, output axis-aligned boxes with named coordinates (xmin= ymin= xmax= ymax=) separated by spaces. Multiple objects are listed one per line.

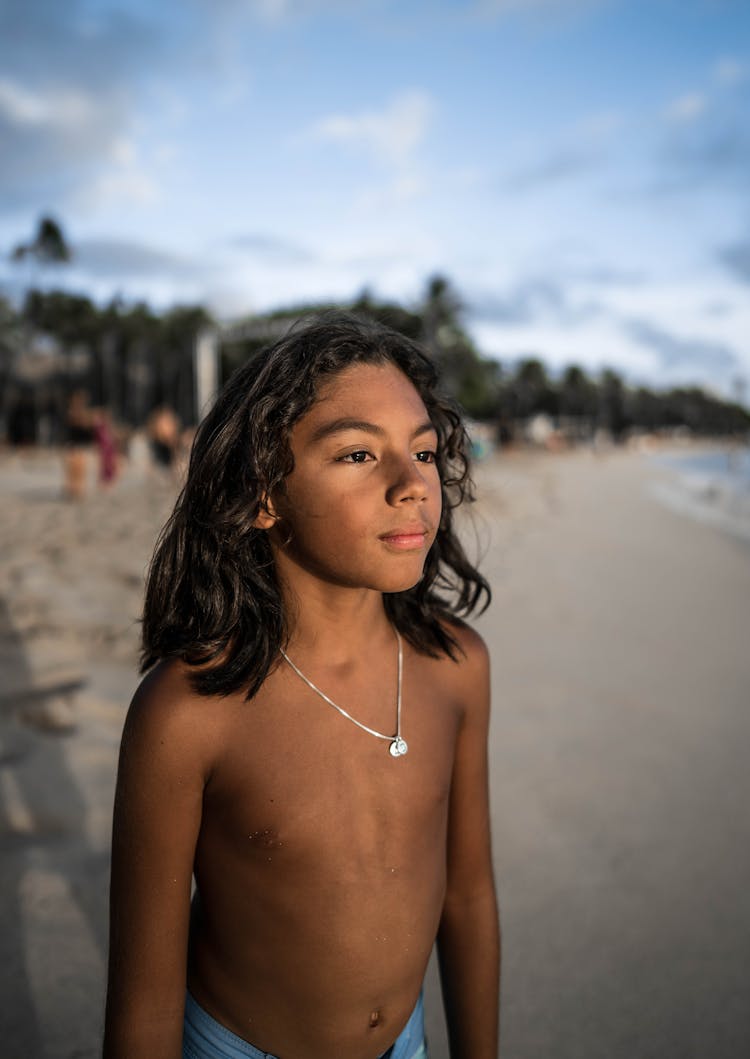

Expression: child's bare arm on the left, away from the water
xmin=104 ymin=671 xmax=208 ymax=1059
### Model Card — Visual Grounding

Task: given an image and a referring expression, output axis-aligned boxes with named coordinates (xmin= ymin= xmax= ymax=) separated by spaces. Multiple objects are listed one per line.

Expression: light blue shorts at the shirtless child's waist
xmin=182 ymin=993 xmax=428 ymax=1059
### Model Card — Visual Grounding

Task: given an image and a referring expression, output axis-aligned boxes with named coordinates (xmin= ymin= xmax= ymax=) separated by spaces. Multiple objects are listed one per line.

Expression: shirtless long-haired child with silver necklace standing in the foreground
xmin=104 ymin=313 xmax=499 ymax=1059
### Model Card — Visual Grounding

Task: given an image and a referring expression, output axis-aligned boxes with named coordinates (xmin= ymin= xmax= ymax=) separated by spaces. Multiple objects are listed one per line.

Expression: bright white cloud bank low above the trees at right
xmin=468 ymin=264 xmax=750 ymax=393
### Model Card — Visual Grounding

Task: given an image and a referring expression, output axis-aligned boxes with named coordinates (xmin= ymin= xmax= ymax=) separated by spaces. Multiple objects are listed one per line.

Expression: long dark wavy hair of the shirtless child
xmin=141 ymin=312 xmax=490 ymax=699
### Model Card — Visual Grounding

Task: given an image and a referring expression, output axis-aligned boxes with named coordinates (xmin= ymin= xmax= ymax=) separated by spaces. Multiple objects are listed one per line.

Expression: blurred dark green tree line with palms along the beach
xmin=0 ymin=218 xmax=750 ymax=442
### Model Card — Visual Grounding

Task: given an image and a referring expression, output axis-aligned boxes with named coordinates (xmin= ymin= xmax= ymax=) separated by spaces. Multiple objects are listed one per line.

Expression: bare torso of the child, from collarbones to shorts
xmin=189 ymin=650 xmax=462 ymax=1059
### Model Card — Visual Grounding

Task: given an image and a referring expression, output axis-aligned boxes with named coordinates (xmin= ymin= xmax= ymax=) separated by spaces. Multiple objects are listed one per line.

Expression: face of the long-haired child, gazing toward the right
xmin=258 ymin=363 xmax=441 ymax=592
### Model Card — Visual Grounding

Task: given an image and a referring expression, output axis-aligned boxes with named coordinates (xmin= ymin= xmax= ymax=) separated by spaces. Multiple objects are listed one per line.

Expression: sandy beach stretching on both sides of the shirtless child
xmin=0 ymin=442 xmax=750 ymax=1059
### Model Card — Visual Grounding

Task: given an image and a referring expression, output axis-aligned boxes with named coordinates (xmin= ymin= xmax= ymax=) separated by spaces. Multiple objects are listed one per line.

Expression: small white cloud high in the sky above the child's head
xmin=308 ymin=91 xmax=433 ymax=166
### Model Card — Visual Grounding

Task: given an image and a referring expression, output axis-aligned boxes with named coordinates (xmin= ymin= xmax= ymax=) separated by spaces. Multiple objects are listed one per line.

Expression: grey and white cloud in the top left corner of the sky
xmin=0 ymin=0 xmax=168 ymax=216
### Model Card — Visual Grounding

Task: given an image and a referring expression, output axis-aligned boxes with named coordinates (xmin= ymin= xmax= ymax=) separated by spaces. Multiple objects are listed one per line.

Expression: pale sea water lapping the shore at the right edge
xmin=649 ymin=445 xmax=750 ymax=543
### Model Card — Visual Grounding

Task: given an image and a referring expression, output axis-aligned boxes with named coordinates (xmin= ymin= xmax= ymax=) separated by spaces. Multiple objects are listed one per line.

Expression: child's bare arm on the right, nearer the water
xmin=438 ymin=629 xmax=500 ymax=1059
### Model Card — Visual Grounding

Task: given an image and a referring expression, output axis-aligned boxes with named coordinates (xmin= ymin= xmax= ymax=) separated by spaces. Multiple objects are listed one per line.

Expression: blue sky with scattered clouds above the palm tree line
xmin=0 ymin=0 xmax=750 ymax=396
